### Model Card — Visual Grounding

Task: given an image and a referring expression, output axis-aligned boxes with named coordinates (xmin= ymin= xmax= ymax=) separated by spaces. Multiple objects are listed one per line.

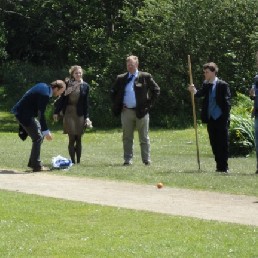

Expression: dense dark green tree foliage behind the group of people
xmin=0 ymin=0 xmax=258 ymax=135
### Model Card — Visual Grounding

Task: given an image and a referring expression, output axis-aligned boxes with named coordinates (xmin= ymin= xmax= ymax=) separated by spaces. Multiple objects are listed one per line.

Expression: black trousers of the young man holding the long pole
xmin=207 ymin=117 xmax=229 ymax=171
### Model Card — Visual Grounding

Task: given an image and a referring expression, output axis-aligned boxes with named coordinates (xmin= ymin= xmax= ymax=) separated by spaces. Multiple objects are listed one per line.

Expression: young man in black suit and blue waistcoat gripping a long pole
xmin=188 ymin=62 xmax=231 ymax=173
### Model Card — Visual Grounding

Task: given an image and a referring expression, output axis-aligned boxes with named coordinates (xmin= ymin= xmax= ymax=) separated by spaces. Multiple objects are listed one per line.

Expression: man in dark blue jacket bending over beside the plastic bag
xmin=11 ymin=80 xmax=66 ymax=172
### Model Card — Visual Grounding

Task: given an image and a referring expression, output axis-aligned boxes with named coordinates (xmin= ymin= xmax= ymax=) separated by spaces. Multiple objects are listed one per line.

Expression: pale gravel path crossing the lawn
xmin=0 ymin=170 xmax=258 ymax=226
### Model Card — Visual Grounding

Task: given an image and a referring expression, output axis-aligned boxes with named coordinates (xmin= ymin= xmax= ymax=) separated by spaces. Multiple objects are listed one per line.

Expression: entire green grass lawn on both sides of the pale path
xmin=0 ymin=112 xmax=258 ymax=257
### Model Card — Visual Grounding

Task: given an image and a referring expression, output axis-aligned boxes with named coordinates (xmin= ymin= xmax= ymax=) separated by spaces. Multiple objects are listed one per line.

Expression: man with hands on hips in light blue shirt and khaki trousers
xmin=111 ymin=56 xmax=160 ymax=166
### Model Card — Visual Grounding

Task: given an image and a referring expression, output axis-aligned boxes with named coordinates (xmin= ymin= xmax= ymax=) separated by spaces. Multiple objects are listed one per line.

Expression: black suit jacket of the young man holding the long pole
xmin=195 ymin=80 xmax=231 ymax=123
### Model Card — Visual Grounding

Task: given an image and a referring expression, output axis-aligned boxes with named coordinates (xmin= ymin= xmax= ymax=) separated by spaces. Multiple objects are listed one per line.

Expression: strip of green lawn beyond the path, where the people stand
xmin=0 ymin=124 xmax=258 ymax=196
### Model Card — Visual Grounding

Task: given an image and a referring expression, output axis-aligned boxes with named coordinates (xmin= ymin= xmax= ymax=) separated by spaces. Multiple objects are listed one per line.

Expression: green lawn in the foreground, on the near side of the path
xmin=0 ymin=191 xmax=258 ymax=258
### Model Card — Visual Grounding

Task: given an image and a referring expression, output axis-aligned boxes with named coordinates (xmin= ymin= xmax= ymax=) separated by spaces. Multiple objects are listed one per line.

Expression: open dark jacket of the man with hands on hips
xmin=111 ymin=71 xmax=160 ymax=118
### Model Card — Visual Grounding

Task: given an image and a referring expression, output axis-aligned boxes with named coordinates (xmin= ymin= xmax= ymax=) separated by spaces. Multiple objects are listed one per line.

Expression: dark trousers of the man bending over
xmin=21 ymin=118 xmax=44 ymax=169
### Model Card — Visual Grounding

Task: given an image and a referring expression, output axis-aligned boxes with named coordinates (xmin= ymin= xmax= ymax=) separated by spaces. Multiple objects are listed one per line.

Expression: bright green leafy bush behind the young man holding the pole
xmin=229 ymin=93 xmax=255 ymax=156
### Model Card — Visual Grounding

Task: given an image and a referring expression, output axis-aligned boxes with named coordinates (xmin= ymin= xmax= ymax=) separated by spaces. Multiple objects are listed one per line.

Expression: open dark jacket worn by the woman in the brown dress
xmin=54 ymin=82 xmax=90 ymax=119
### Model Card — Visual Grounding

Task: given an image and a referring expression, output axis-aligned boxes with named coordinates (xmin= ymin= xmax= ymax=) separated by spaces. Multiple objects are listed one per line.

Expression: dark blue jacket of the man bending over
xmin=11 ymin=83 xmax=52 ymax=131
